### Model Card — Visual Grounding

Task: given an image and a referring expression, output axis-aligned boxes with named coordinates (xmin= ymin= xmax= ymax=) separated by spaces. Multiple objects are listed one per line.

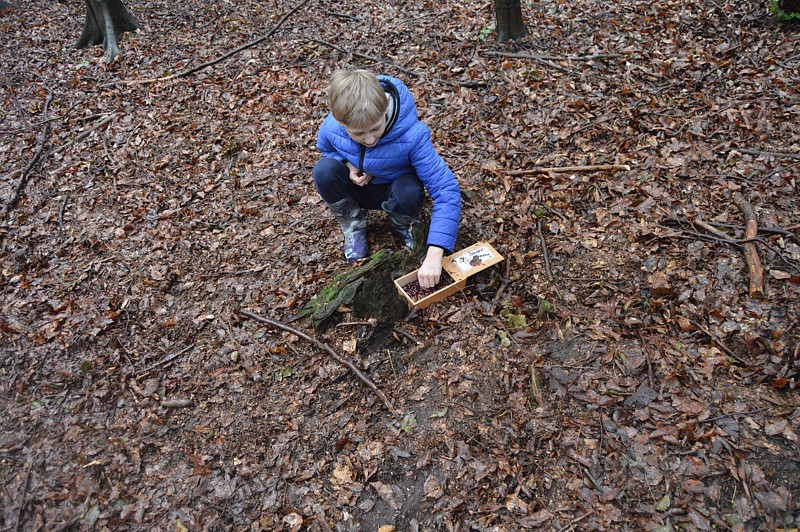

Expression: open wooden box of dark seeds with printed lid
xmin=394 ymin=242 xmax=503 ymax=310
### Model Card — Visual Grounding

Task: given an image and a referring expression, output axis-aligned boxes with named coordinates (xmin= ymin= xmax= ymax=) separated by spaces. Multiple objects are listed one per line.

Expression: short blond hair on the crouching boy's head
xmin=328 ymin=70 xmax=389 ymax=128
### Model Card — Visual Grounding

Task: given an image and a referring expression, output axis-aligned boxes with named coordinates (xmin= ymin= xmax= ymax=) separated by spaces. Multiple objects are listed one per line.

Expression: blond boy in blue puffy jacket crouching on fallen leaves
xmin=313 ymin=70 xmax=461 ymax=288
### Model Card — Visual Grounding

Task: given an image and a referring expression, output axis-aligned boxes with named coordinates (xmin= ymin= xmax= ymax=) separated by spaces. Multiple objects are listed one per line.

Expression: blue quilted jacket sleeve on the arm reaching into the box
xmin=411 ymin=128 xmax=461 ymax=251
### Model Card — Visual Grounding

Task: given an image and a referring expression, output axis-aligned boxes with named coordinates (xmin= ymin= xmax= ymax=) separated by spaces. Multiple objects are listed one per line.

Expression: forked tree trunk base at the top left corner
xmin=75 ymin=0 xmax=139 ymax=63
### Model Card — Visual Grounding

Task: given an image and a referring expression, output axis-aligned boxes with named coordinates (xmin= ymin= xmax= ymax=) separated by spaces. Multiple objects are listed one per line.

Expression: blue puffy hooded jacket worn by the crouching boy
xmin=317 ymin=76 xmax=461 ymax=251
